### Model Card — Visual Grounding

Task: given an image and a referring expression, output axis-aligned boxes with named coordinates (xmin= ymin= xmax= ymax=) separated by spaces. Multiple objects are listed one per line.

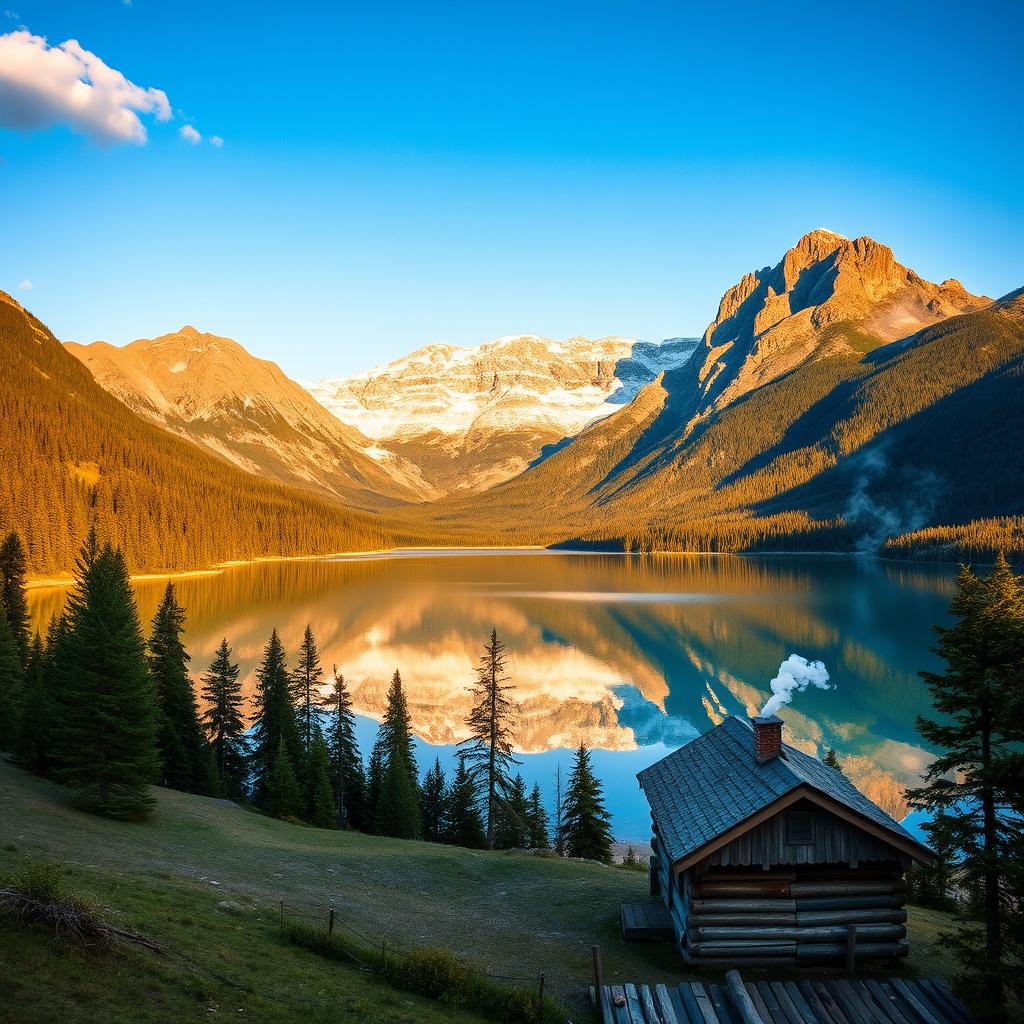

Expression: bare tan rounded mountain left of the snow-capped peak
xmin=66 ymin=327 xmax=437 ymax=508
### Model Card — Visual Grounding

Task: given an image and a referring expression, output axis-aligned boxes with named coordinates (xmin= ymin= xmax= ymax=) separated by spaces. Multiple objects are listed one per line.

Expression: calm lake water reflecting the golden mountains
xmin=30 ymin=552 xmax=954 ymax=842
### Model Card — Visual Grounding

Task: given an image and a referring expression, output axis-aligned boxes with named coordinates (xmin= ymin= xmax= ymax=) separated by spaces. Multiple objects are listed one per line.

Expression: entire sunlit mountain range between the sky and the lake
xmin=0 ymin=230 xmax=1024 ymax=570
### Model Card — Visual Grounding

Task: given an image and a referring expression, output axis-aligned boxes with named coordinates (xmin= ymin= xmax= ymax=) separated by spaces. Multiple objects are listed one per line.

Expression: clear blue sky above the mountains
xmin=0 ymin=0 xmax=1024 ymax=379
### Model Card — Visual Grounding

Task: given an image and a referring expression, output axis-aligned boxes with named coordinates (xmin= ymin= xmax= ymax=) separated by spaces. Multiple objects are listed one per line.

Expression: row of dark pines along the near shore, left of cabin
xmin=0 ymin=529 xmax=612 ymax=862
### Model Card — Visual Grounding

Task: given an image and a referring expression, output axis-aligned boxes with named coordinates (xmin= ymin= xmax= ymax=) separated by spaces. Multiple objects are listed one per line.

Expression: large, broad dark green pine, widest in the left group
xmin=54 ymin=529 xmax=160 ymax=819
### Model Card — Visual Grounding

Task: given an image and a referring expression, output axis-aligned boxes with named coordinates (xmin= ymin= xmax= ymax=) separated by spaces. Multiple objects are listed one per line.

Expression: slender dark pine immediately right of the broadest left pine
xmin=147 ymin=582 xmax=206 ymax=793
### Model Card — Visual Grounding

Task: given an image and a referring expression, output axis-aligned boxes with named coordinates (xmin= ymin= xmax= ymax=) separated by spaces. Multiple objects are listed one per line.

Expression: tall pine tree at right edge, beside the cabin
xmin=907 ymin=555 xmax=1024 ymax=1021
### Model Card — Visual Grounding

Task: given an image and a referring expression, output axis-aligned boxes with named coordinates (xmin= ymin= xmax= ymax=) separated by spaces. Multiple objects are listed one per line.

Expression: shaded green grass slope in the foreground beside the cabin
xmin=0 ymin=760 xmax=949 ymax=1024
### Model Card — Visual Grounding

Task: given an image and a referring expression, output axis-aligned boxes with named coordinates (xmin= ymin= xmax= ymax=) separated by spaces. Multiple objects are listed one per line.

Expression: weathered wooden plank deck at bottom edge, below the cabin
xmin=591 ymin=971 xmax=975 ymax=1024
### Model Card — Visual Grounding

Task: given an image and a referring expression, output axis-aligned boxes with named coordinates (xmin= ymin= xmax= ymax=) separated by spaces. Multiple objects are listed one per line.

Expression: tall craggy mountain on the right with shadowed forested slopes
xmin=401 ymin=232 xmax=1024 ymax=554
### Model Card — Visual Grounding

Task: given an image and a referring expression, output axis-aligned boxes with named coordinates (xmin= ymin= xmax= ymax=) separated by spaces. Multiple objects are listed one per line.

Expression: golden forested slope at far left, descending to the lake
xmin=0 ymin=292 xmax=432 ymax=572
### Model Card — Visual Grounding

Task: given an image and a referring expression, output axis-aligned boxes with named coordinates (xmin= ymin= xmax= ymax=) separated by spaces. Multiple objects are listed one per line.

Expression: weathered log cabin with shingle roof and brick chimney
xmin=637 ymin=715 xmax=934 ymax=966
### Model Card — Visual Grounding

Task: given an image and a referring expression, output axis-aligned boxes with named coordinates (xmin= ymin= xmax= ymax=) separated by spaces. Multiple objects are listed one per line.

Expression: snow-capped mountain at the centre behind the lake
xmin=308 ymin=335 xmax=699 ymax=493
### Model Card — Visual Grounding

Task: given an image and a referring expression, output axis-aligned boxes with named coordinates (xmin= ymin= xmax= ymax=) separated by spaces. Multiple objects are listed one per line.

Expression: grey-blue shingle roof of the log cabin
xmin=637 ymin=716 xmax=924 ymax=863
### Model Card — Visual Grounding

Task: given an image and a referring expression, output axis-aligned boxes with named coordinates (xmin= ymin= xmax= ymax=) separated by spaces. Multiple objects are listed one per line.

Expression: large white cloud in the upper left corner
xmin=0 ymin=29 xmax=171 ymax=145
